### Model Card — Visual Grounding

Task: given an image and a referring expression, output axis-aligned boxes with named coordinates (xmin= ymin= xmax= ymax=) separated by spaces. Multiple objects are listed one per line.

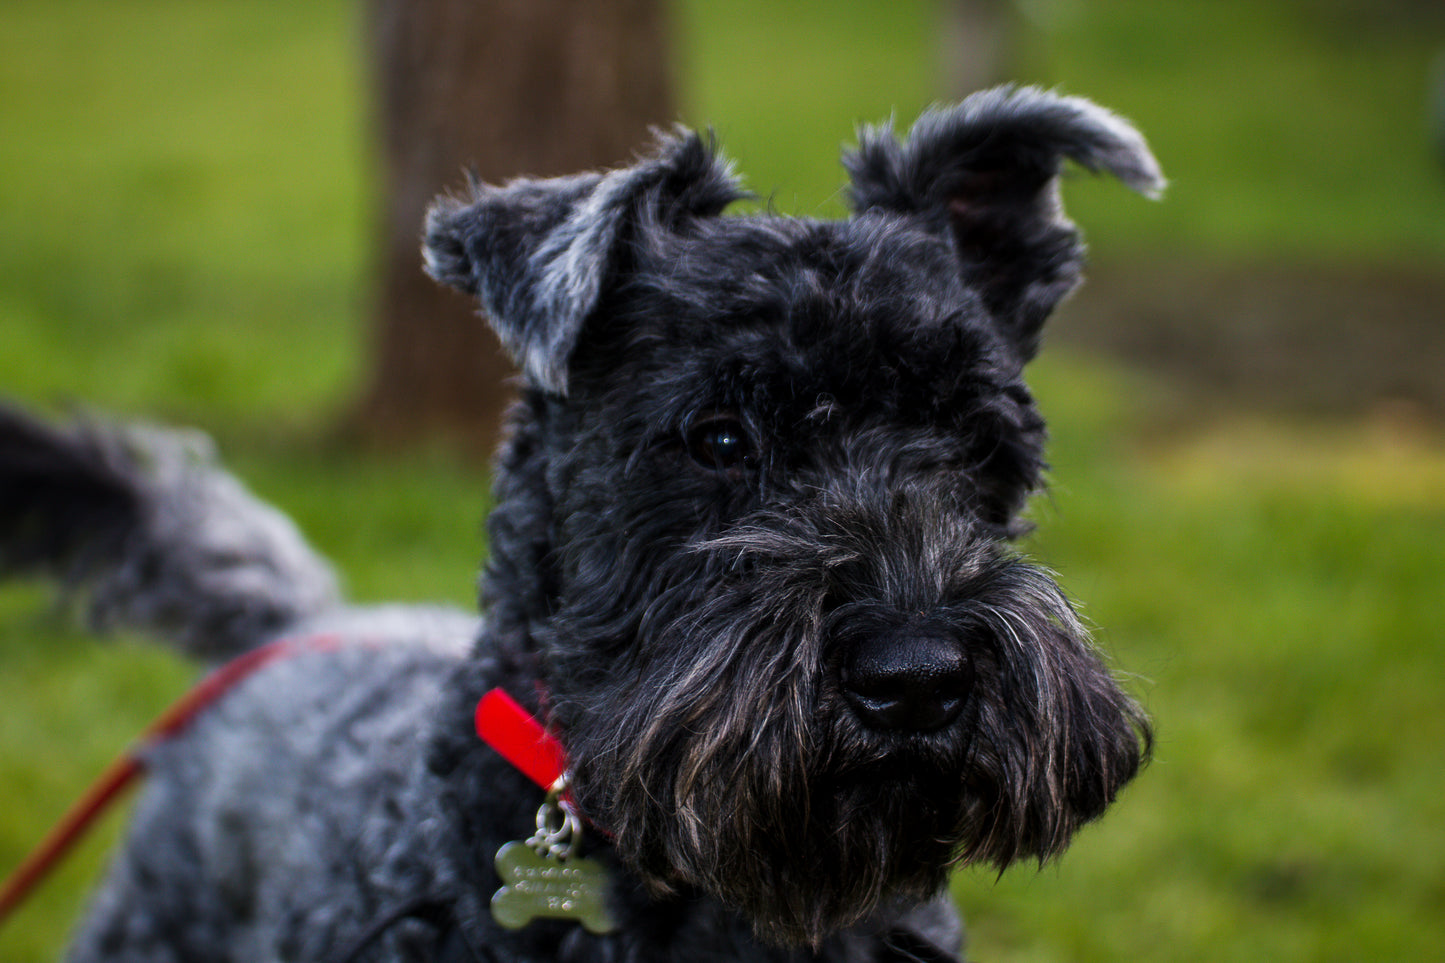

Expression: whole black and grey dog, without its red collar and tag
xmin=0 ymin=90 xmax=1162 ymax=963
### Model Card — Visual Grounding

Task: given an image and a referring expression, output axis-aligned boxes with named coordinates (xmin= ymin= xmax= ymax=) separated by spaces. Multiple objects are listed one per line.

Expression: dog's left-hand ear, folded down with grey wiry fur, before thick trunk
xmin=422 ymin=129 xmax=743 ymax=395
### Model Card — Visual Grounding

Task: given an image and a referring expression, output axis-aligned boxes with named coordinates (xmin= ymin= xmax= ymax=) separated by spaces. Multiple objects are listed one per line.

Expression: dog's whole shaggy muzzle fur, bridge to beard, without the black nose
xmin=552 ymin=497 xmax=1149 ymax=944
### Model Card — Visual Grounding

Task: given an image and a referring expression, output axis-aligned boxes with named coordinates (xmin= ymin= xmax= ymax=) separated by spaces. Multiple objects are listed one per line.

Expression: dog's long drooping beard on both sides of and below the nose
xmin=554 ymin=557 xmax=1147 ymax=946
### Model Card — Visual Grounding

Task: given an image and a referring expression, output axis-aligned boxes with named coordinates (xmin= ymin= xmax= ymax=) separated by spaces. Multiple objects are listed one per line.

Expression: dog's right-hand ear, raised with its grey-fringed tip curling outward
xmin=844 ymin=87 xmax=1165 ymax=359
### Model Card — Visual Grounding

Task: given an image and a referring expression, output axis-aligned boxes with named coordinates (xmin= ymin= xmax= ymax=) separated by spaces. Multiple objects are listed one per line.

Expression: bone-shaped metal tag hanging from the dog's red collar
xmin=491 ymin=843 xmax=617 ymax=933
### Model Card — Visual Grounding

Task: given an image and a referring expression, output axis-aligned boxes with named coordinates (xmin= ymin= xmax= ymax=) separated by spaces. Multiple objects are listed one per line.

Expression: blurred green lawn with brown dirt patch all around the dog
xmin=0 ymin=0 xmax=1445 ymax=963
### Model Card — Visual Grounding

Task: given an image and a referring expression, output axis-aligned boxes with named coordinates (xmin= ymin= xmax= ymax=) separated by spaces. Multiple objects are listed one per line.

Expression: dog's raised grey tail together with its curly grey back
xmin=0 ymin=406 xmax=477 ymax=960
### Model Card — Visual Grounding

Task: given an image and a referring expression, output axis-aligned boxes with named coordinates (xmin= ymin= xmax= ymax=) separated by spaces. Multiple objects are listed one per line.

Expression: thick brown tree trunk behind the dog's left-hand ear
xmin=357 ymin=0 xmax=673 ymax=453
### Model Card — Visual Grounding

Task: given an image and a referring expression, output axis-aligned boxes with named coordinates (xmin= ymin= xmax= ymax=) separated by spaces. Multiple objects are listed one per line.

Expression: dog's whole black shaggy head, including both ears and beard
xmin=426 ymin=91 xmax=1160 ymax=943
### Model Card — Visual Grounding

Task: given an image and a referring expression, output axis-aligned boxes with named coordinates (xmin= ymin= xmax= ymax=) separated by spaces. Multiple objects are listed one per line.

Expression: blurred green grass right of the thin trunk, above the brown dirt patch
xmin=1023 ymin=0 xmax=1445 ymax=263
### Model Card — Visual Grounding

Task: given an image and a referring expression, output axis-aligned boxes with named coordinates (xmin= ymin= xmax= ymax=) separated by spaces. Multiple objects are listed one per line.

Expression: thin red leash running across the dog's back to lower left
xmin=0 ymin=635 xmax=341 ymax=925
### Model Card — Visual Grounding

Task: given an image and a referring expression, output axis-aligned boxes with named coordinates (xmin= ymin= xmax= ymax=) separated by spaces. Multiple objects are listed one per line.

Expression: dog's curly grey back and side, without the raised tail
xmin=69 ymin=613 xmax=468 ymax=963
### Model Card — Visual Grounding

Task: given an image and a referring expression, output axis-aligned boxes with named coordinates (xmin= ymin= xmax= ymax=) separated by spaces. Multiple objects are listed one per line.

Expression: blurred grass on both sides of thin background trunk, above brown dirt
xmin=681 ymin=0 xmax=1445 ymax=263
